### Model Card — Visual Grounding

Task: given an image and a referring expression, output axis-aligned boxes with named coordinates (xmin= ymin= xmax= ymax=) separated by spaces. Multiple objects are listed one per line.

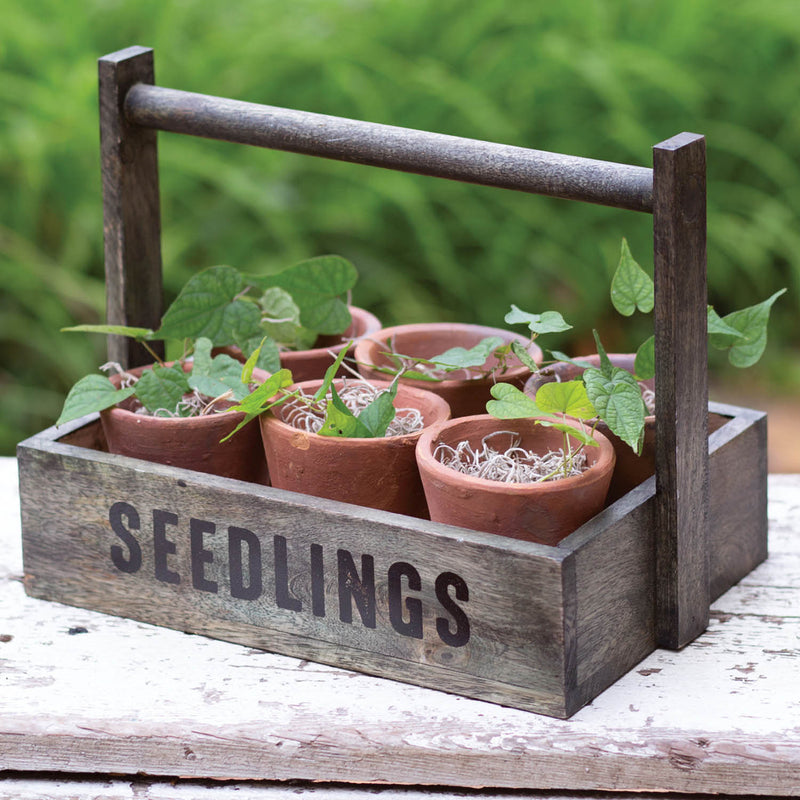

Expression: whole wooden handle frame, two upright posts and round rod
xmin=95 ymin=47 xmax=709 ymax=648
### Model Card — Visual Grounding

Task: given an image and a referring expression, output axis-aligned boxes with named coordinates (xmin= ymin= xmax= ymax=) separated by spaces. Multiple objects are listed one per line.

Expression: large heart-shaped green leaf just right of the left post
xmin=155 ymin=266 xmax=263 ymax=347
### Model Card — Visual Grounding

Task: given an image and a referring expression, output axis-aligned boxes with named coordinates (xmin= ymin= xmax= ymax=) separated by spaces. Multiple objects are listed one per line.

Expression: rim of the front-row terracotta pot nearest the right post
xmin=417 ymin=414 xmax=616 ymax=495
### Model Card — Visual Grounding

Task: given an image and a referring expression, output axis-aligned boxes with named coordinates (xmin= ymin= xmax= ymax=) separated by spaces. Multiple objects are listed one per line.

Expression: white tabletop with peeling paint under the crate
xmin=0 ymin=458 xmax=800 ymax=800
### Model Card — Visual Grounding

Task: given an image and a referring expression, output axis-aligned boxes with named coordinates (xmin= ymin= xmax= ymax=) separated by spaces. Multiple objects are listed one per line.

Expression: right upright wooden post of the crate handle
xmin=653 ymin=134 xmax=710 ymax=648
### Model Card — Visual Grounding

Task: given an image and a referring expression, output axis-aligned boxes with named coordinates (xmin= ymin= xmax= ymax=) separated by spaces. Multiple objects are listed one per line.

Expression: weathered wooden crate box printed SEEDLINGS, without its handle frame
xmin=12 ymin=407 xmax=766 ymax=717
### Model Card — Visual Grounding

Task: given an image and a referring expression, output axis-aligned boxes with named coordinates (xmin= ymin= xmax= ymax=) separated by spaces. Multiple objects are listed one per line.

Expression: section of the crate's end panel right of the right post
xmin=709 ymin=410 xmax=768 ymax=600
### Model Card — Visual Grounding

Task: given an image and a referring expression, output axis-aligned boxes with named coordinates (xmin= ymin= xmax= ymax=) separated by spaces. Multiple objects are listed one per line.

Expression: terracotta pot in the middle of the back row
xmin=355 ymin=322 xmax=542 ymax=417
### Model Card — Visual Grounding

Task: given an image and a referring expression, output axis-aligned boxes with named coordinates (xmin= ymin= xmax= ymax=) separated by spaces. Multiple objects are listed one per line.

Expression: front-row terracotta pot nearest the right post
xmin=417 ymin=414 xmax=615 ymax=545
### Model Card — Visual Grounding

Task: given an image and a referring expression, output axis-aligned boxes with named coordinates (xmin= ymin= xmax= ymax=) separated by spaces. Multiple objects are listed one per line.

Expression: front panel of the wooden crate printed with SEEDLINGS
xmin=19 ymin=445 xmax=565 ymax=716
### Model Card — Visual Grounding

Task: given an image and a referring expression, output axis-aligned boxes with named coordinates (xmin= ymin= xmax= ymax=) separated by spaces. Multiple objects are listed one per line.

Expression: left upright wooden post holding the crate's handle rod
xmin=98 ymin=47 xmax=163 ymax=367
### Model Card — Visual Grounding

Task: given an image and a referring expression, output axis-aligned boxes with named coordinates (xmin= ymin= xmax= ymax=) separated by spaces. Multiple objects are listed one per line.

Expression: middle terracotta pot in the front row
xmin=260 ymin=380 xmax=450 ymax=517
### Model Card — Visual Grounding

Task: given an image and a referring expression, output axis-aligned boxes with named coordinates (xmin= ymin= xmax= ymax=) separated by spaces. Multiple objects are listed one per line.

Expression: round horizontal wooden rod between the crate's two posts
xmin=125 ymin=84 xmax=653 ymax=212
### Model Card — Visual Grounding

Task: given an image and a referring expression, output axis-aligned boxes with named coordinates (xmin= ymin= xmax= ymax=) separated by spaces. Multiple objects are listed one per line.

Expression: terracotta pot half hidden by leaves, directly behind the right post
xmin=525 ymin=353 xmax=656 ymax=503
